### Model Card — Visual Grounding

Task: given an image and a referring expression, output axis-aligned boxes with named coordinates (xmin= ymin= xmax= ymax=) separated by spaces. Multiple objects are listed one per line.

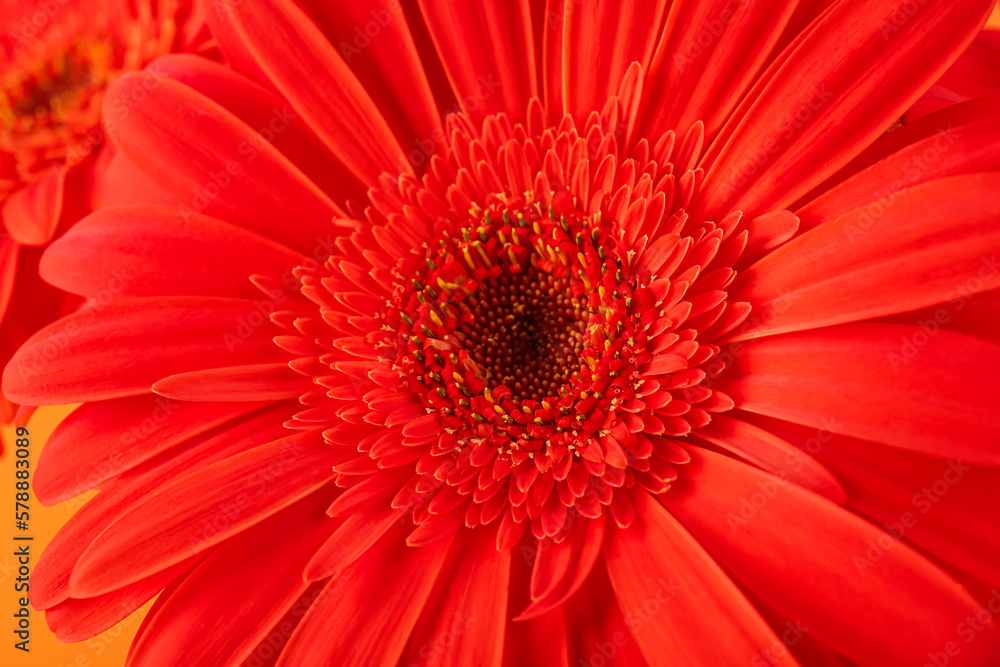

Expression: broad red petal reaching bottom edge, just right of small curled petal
xmin=604 ymin=494 xmax=797 ymax=666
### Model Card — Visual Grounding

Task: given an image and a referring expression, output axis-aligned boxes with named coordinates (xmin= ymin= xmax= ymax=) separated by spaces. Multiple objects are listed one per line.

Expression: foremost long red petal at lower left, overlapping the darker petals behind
xmin=70 ymin=433 xmax=334 ymax=596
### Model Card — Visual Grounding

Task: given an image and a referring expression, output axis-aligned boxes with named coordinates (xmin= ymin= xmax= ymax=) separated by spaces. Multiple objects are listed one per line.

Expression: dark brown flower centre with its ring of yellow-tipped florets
xmin=386 ymin=190 xmax=637 ymax=453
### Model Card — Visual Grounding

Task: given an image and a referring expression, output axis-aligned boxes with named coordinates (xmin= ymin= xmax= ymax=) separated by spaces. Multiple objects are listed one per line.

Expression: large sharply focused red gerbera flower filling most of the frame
xmin=4 ymin=0 xmax=1000 ymax=666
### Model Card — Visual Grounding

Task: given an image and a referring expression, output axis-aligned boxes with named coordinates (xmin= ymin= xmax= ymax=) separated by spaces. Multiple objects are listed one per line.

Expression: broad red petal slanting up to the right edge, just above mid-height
xmin=730 ymin=174 xmax=1000 ymax=338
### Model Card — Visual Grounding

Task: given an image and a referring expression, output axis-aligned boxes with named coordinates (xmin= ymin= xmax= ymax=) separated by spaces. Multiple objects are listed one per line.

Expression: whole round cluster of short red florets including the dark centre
xmin=289 ymin=101 xmax=747 ymax=543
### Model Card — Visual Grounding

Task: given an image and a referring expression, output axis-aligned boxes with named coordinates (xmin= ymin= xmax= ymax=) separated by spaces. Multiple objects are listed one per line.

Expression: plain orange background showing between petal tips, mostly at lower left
xmin=0 ymin=8 xmax=1000 ymax=667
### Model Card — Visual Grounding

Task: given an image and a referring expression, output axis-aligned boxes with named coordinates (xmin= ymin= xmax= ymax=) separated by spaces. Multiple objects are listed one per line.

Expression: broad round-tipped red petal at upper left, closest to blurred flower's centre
xmin=104 ymin=72 xmax=343 ymax=256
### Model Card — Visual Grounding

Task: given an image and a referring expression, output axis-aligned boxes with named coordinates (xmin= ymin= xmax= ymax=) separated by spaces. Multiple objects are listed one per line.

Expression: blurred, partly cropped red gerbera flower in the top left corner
xmin=0 ymin=0 xmax=207 ymax=421
